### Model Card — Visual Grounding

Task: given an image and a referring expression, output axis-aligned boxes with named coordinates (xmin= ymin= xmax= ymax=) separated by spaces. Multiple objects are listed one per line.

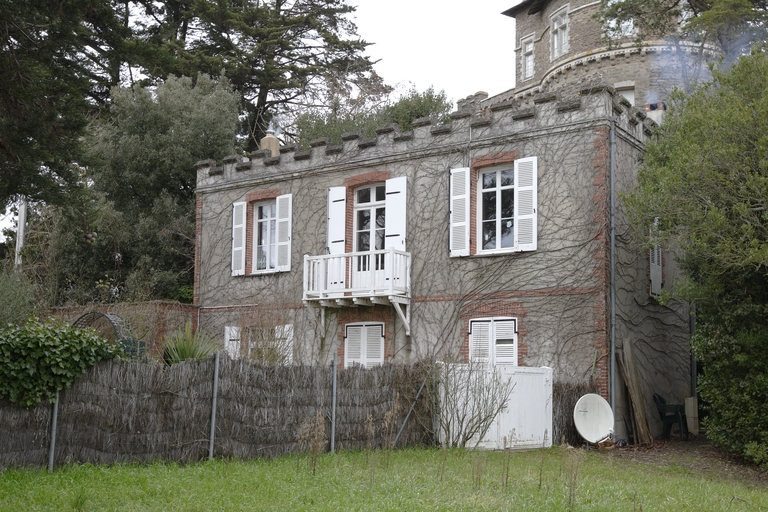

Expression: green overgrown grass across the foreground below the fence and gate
xmin=0 ymin=447 xmax=768 ymax=511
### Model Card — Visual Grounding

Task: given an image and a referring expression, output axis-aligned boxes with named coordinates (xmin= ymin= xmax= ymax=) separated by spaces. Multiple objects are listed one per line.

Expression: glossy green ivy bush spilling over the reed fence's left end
xmin=0 ymin=318 xmax=118 ymax=407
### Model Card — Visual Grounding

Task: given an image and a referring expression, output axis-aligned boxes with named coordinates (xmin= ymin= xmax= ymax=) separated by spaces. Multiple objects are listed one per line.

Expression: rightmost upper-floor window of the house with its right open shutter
xmin=477 ymin=157 xmax=537 ymax=254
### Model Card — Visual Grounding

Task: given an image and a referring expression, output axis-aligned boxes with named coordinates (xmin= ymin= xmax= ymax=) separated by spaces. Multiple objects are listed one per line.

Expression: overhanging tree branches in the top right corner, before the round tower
xmin=599 ymin=0 xmax=768 ymax=59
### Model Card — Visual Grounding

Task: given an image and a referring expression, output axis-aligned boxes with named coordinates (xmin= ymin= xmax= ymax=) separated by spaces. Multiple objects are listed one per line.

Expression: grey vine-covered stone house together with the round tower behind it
xmin=195 ymin=0 xmax=691 ymax=438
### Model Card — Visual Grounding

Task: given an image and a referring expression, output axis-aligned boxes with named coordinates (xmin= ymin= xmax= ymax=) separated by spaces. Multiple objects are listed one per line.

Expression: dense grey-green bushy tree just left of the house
xmin=20 ymin=75 xmax=239 ymax=305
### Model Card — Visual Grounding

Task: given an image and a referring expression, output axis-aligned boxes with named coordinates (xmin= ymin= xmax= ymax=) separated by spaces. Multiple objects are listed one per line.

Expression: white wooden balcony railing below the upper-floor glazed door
xmin=304 ymin=248 xmax=411 ymax=302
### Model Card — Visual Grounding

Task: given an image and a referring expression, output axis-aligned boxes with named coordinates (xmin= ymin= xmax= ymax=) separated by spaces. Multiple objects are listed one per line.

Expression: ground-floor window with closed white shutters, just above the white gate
xmin=469 ymin=317 xmax=517 ymax=366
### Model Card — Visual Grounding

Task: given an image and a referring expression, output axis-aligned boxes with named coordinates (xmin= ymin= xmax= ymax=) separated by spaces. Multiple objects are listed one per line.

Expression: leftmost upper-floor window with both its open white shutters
xmin=232 ymin=194 xmax=293 ymax=276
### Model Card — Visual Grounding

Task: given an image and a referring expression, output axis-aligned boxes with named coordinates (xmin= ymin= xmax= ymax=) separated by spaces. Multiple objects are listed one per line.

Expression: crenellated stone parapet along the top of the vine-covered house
xmin=196 ymin=83 xmax=655 ymax=190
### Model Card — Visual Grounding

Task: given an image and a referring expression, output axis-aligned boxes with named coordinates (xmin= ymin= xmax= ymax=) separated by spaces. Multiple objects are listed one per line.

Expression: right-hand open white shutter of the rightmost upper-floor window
xmin=515 ymin=156 xmax=538 ymax=251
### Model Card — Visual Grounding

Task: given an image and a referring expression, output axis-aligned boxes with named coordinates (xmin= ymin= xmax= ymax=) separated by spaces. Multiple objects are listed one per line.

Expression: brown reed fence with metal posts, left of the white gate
xmin=0 ymin=356 xmax=430 ymax=467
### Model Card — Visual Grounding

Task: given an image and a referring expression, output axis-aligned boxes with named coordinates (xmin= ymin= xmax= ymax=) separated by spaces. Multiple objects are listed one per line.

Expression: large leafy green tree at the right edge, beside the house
xmin=626 ymin=52 xmax=768 ymax=464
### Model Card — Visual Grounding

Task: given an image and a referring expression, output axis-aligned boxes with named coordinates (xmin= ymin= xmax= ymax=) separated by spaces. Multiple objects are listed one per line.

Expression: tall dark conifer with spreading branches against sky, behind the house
xmin=137 ymin=0 xmax=381 ymax=151
